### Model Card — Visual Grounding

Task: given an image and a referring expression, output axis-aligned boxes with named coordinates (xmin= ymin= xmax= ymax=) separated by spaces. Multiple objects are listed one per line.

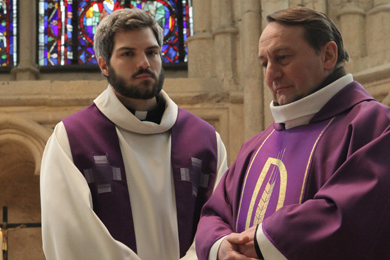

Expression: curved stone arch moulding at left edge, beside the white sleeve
xmin=0 ymin=115 xmax=51 ymax=175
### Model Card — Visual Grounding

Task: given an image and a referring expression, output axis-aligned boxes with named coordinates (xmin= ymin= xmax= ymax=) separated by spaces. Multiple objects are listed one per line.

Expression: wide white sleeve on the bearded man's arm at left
xmin=40 ymin=122 xmax=140 ymax=260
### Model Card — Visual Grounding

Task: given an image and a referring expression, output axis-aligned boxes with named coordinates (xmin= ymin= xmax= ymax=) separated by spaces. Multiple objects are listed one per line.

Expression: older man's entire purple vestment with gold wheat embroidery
xmin=196 ymin=82 xmax=390 ymax=260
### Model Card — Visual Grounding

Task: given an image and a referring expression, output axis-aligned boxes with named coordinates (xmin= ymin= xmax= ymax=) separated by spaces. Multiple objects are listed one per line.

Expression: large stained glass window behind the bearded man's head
xmin=38 ymin=0 xmax=192 ymax=66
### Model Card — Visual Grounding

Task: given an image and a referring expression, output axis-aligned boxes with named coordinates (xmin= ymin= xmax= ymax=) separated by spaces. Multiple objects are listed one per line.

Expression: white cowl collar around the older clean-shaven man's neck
xmin=270 ymin=74 xmax=353 ymax=129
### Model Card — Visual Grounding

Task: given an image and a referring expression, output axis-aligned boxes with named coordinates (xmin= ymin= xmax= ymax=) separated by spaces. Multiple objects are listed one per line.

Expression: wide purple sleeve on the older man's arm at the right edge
xmin=263 ymin=127 xmax=390 ymax=260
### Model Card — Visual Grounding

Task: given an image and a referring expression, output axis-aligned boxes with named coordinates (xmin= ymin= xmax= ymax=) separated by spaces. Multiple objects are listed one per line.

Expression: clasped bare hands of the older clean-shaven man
xmin=218 ymin=233 xmax=257 ymax=260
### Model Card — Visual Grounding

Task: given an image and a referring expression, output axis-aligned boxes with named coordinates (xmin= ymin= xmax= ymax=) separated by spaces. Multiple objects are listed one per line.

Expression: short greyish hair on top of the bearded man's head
xmin=93 ymin=8 xmax=163 ymax=64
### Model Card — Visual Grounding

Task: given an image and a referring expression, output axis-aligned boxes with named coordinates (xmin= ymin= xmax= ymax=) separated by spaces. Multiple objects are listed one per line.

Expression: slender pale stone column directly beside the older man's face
xmin=240 ymin=0 xmax=264 ymax=140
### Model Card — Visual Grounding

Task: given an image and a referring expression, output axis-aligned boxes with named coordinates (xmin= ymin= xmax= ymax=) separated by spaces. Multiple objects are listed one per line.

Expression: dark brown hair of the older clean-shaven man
xmin=267 ymin=7 xmax=349 ymax=66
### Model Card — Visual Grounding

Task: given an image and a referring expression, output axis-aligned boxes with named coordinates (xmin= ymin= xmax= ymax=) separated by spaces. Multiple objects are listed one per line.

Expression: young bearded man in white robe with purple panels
xmin=41 ymin=9 xmax=227 ymax=260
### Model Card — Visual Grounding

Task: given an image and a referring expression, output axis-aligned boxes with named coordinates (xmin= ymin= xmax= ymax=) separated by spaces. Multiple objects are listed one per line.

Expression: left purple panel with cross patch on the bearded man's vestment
xmin=63 ymin=104 xmax=136 ymax=252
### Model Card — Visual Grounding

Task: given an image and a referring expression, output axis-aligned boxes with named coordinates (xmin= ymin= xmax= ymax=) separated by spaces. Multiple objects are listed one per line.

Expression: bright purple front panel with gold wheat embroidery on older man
xmin=236 ymin=120 xmax=331 ymax=232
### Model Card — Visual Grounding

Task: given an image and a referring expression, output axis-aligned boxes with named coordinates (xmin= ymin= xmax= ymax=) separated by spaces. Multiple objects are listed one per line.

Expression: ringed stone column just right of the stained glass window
xmin=187 ymin=0 xmax=215 ymax=78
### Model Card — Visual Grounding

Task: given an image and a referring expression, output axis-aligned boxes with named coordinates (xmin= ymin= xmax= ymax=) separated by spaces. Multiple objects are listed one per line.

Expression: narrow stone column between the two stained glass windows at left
xmin=11 ymin=0 xmax=39 ymax=80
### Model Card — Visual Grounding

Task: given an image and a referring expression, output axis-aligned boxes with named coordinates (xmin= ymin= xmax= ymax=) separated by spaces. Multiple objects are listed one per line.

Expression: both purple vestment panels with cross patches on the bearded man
xmin=63 ymin=104 xmax=217 ymax=257
